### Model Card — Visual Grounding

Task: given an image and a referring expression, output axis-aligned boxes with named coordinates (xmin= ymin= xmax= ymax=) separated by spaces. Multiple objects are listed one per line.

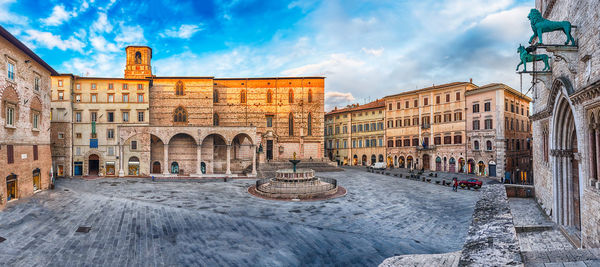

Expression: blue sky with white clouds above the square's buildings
xmin=0 ymin=0 xmax=534 ymax=110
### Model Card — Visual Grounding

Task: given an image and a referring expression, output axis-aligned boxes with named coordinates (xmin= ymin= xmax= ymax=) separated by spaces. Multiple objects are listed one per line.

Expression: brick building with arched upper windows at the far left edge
xmin=0 ymin=26 xmax=57 ymax=209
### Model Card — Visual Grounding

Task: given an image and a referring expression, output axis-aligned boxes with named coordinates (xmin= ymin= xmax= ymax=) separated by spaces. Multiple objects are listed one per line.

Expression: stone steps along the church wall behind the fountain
xmin=257 ymin=160 xmax=343 ymax=178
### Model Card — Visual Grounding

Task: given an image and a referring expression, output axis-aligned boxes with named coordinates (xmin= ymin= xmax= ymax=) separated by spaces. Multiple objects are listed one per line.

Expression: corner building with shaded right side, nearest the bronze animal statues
xmin=465 ymin=83 xmax=532 ymax=180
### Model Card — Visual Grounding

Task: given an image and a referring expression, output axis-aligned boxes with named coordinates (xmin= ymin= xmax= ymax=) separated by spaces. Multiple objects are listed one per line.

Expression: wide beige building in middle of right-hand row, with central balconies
xmin=384 ymin=82 xmax=477 ymax=172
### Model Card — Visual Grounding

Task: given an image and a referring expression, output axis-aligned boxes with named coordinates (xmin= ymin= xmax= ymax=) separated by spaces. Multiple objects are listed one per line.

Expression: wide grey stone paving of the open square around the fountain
xmin=0 ymin=170 xmax=479 ymax=266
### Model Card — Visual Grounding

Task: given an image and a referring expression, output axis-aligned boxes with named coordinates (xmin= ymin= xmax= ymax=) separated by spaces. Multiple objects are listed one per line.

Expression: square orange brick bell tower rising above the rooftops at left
xmin=125 ymin=46 xmax=152 ymax=79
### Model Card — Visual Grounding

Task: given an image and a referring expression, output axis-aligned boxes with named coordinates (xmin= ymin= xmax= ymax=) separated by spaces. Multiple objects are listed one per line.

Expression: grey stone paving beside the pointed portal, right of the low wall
xmin=509 ymin=198 xmax=600 ymax=267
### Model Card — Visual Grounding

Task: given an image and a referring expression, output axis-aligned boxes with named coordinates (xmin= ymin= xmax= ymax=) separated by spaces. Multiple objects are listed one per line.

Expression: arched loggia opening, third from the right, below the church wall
xmin=167 ymin=132 xmax=198 ymax=175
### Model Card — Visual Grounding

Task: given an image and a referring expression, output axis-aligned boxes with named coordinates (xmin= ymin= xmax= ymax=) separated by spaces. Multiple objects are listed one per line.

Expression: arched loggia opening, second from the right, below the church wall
xmin=200 ymin=133 xmax=230 ymax=174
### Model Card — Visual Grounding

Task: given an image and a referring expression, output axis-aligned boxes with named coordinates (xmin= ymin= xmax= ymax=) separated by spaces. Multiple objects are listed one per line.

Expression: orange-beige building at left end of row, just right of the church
xmin=325 ymin=99 xmax=385 ymax=166
